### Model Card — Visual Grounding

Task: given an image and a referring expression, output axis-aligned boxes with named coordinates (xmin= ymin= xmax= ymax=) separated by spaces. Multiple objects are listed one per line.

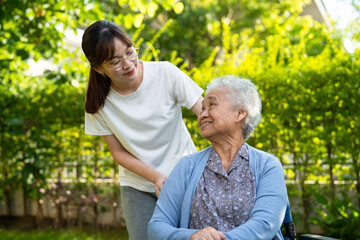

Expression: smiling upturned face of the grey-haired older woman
xmin=198 ymin=87 xmax=242 ymax=141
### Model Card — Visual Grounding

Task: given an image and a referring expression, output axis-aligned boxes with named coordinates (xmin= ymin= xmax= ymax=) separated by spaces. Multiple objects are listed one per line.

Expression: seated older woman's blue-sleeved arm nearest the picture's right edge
xmin=225 ymin=157 xmax=288 ymax=240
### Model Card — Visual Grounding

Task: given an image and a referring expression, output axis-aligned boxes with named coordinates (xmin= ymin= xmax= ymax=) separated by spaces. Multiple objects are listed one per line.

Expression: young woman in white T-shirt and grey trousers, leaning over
xmin=82 ymin=20 xmax=203 ymax=240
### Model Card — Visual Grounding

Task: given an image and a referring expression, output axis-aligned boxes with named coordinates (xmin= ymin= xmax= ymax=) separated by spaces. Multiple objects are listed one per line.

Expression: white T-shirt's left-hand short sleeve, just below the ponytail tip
xmin=85 ymin=112 xmax=113 ymax=136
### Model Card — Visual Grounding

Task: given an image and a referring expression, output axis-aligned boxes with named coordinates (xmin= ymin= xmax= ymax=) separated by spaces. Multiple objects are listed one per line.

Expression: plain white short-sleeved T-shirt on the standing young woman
xmin=85 ymin=61 xmax=203 ymax=192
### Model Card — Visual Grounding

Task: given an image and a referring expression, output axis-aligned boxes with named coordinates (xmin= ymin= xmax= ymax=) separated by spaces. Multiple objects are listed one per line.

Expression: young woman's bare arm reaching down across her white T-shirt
xmin=103 ymin=134 xmax=167 ymax=197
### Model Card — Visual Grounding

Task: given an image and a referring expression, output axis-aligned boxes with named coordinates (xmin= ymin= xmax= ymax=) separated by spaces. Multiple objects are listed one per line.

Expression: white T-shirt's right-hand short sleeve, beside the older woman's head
xmin=168 ymin=63 xmax=204 ymax=109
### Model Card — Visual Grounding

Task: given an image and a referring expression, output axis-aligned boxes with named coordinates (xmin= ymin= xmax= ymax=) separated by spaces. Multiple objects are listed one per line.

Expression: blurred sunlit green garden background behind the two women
xmin=0 ymin=0 xmax=360 ymax=240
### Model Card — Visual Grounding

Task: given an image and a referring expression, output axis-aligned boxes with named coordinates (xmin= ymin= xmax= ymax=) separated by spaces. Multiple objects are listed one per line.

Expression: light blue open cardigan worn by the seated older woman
xmin=148 ymin=145 xmax=288 ymax=240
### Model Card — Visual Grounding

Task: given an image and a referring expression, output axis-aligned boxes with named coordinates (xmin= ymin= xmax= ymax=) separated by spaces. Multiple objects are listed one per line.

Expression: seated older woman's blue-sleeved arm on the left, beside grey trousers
xmin=148 ymin=159 xmax=196 ymax=240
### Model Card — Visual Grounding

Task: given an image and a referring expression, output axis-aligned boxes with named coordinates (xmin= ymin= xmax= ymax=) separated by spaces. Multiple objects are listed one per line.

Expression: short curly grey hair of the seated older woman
xmin=206 ymin=75 xmax=262 ymax=140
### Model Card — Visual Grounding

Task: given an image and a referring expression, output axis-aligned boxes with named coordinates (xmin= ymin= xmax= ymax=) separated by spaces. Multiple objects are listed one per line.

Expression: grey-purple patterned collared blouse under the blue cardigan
xmin=189 ymin=144 xmax=256 ymax=232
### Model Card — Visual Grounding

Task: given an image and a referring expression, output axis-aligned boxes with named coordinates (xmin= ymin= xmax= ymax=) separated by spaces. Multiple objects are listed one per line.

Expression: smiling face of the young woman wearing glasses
xmin=99 ymin=39 xmax=139 ymax=84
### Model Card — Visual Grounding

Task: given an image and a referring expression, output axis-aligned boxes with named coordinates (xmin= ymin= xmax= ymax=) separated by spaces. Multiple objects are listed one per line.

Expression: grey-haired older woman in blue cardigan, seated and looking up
xmin=148 ymin=75 xmax=288 ymax=240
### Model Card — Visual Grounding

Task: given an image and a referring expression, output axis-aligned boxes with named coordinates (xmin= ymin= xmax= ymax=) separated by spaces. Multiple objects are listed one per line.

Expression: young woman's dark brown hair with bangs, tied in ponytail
xmin=81 ymin=20 xmax=132 ymax=114
